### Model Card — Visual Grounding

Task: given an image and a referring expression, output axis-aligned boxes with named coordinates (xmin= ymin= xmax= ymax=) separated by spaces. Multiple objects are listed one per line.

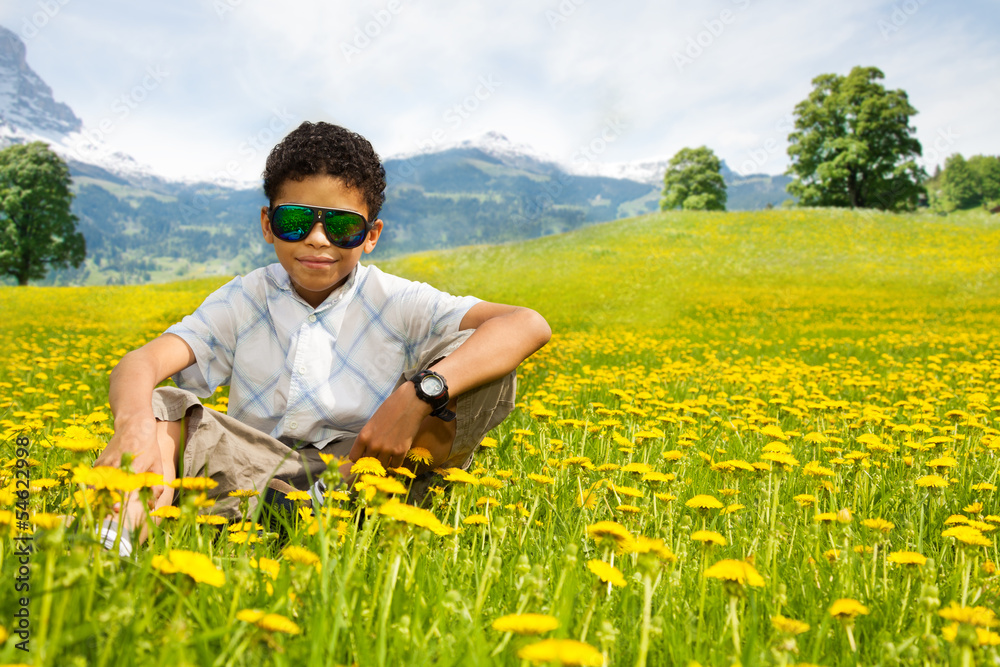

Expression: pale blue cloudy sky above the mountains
xmin=0 ymin=0 xmax=1000 ymax=182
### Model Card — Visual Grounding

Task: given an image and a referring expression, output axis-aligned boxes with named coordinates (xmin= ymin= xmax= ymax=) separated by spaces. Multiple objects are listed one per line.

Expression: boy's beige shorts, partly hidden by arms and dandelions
xmin=153 ymin=330 xmax=516 ymax=520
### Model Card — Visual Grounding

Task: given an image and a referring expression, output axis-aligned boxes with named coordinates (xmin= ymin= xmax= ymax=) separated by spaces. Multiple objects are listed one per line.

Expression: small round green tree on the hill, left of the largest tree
xmin=660 ymin=146 xmax=726 ymax=211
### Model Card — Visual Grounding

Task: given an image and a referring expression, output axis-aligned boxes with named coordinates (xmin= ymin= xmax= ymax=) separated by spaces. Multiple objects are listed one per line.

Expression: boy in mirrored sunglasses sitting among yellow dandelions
xmin=95 ymin=122 xmax=551 ymax=553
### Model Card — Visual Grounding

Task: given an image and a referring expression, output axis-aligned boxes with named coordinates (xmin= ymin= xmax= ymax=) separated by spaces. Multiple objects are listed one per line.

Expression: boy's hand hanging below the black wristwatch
xmin=348 ymin=382 xmax=431 ymax=468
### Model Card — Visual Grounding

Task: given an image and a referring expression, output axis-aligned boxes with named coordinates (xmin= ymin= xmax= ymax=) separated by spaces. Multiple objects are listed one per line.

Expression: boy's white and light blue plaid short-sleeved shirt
xmin=167 ymin=264 xmax=479 ymax=448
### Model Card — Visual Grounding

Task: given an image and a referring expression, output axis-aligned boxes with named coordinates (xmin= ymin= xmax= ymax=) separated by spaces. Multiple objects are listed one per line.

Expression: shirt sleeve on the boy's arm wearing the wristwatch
xmin=399 ymin=282 xmax=481 ymax=367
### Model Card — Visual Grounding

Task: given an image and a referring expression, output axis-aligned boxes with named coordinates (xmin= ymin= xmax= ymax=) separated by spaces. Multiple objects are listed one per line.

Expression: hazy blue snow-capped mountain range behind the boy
xmin=0 ymin=27 xmax=788 ymax=284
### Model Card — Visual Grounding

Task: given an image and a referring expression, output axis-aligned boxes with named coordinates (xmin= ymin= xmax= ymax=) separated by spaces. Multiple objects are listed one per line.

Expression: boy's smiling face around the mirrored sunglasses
xmin=260 ymin=175 xmax=382 ymax=308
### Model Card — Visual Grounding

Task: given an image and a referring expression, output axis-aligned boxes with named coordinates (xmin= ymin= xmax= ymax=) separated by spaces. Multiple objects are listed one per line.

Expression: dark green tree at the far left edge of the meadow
xmin=0 ymin=141 xmax=86 ymax=285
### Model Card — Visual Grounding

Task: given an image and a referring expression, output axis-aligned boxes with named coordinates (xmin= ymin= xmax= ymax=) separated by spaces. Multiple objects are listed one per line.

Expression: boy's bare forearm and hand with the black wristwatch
xmin=350 ymin=301 xmax=552 ymax=467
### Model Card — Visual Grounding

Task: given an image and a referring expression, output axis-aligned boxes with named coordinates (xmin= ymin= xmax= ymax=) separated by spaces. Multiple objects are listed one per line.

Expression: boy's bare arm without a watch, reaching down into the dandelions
xmin=94 ymin=334 xmax=195 ymax=474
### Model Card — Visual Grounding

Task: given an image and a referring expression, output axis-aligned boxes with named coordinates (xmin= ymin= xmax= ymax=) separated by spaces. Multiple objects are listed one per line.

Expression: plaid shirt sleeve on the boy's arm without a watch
xmin=166 ymin=276 xmax=243 ymax=398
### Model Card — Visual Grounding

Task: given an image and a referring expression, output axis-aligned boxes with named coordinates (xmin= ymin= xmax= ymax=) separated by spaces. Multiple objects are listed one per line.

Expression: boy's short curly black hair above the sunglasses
xmin=261 ymin=121 xmax=385 ymax=220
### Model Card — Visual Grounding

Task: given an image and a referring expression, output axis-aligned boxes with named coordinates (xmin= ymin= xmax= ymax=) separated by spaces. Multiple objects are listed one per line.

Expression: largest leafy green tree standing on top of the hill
xmin=787 ymin=67 xmax=926 ymax=210
